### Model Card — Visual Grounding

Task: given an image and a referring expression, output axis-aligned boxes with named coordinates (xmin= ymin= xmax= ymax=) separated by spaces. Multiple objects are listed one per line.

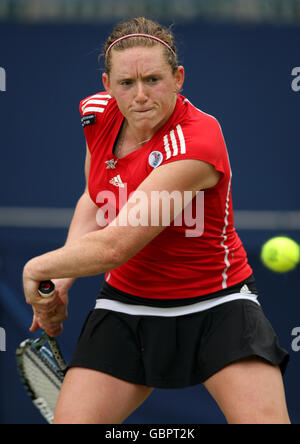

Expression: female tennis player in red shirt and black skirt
xmin=24 ymin=18 xmax=289 ymax=424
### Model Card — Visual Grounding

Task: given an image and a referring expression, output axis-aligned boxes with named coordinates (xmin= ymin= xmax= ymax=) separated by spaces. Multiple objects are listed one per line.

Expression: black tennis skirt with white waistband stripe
xmin=68 ymin=283 xmax=289 ymax=388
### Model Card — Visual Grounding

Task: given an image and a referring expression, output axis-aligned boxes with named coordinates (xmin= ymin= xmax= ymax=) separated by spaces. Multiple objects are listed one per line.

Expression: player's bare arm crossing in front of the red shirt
xmin=24 ymin=159 xmax=219 ymax=288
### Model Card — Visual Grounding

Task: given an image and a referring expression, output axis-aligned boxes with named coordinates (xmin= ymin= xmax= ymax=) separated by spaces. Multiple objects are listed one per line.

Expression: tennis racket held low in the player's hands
xmin=16 ymin=281 xmax=67 ymax=424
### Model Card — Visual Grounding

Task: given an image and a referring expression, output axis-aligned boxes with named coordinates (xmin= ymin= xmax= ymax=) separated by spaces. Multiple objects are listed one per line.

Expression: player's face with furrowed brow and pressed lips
xmin=103 ymin=45 xmax=184 ymax=132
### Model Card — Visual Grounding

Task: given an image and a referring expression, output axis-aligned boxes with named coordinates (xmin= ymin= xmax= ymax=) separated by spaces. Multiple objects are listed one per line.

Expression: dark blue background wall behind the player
xmin=0 ymin=23 xmax=300 ymax=424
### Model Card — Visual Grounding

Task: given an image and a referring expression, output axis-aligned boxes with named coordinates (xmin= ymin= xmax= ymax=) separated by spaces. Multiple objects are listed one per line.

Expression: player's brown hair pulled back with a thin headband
xmin=102 ymin=17 xmax=178 ymax=74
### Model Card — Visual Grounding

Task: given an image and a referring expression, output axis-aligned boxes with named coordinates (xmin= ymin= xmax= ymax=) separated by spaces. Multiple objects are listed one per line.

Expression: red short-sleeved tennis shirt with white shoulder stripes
xmin=80 ymin=92 xmax=252 ymax=299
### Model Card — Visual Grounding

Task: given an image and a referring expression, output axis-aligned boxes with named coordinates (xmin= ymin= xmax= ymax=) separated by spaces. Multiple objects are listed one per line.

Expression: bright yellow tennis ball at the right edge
xmin=261 ymin=236 xmax=300 ymax=273
